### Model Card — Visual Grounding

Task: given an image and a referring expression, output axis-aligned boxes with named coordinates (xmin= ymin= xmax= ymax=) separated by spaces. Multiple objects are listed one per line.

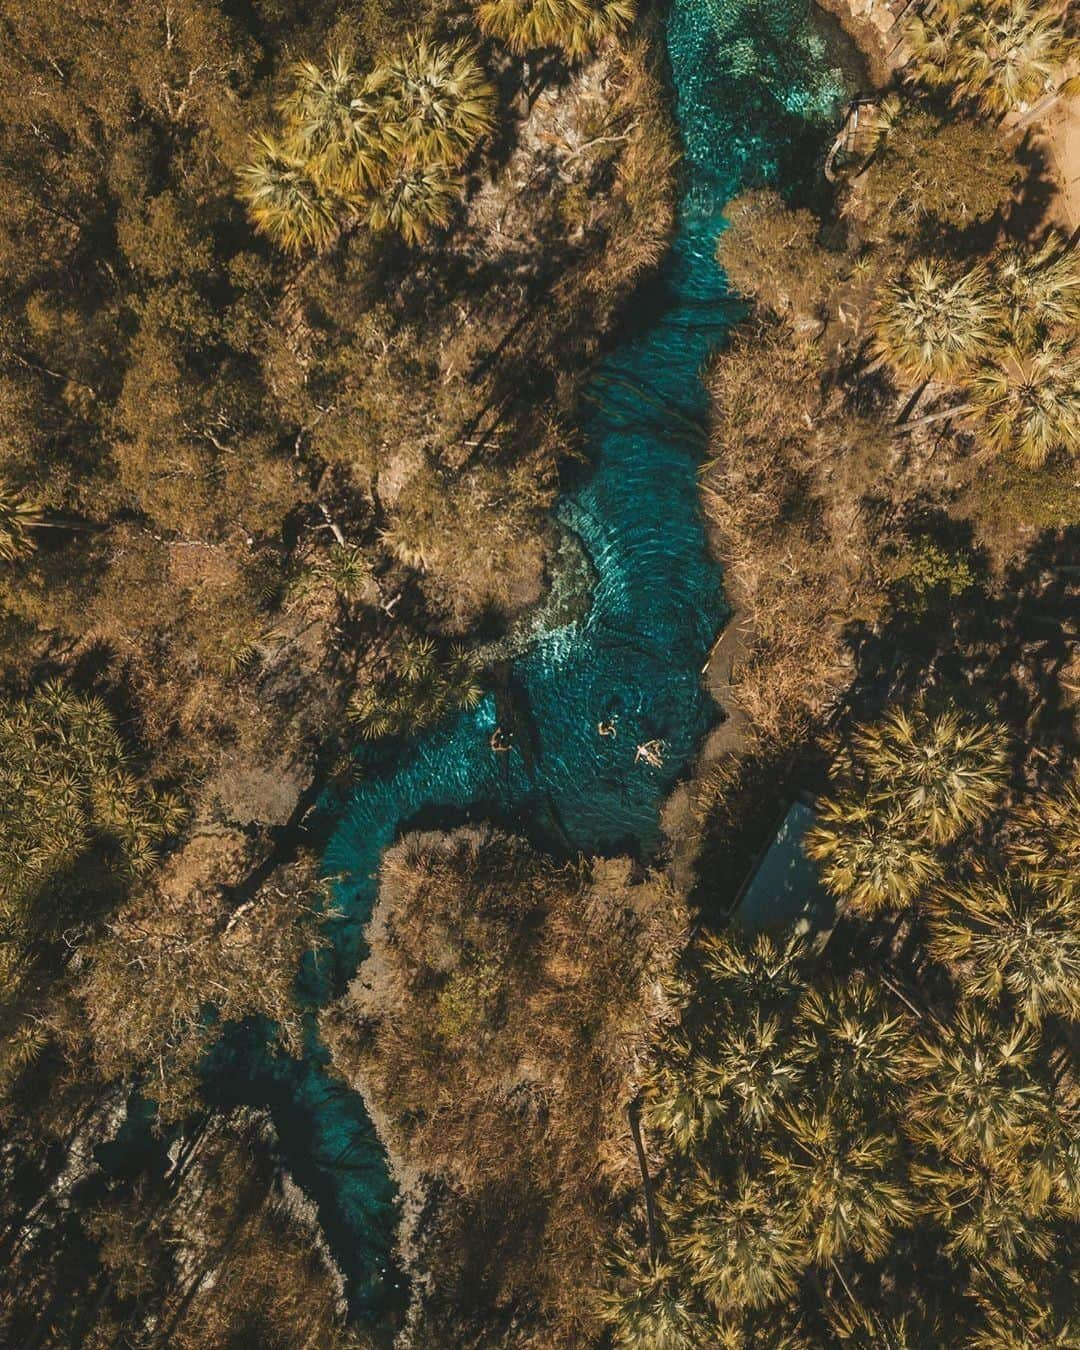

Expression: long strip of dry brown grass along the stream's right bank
xmin=702 ymin=325 xmax=888 ymax=743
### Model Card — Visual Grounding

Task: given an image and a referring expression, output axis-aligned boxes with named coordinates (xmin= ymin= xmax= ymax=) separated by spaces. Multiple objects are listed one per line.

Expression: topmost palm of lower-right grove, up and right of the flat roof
xmin=851 ymin=707 xmax=1008 ymax=844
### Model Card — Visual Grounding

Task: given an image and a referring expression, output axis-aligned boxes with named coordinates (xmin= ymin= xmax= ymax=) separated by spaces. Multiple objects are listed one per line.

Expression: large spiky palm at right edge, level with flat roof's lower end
xmin=929 ymin=871 xmax=1080 ymax=1022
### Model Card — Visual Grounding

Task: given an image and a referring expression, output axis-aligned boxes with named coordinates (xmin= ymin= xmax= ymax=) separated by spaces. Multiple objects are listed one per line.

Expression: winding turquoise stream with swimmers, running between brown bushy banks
xmin=205 ymin=0 xmax=857 ymax=1315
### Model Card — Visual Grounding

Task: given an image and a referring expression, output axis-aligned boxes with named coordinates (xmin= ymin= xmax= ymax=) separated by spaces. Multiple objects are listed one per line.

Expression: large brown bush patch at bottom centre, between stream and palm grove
xmin=323 ymin=828 xmax=686 ymax=1346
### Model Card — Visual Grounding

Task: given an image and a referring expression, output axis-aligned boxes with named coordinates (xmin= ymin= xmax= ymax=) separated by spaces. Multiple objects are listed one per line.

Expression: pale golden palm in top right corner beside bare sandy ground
xmin=906 ymin=0 xmax=1076 ymax=115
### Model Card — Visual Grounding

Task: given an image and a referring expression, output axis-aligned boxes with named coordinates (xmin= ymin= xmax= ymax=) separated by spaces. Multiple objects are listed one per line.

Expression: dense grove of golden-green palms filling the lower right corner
xmin=599 ymin=707 xmax=1080 ymax=1347
